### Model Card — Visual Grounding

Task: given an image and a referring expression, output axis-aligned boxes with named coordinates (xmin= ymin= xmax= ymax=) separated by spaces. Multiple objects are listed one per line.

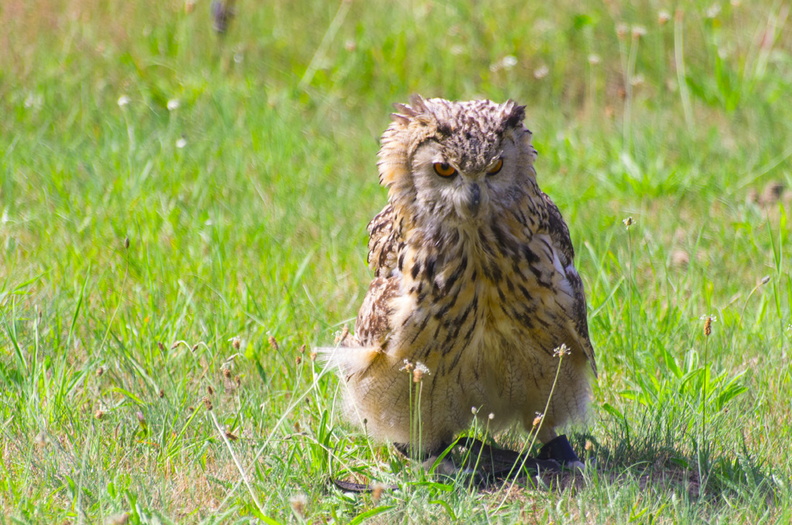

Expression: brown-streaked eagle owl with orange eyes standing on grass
xmin=330 ymin=96 xmax=596 ymax=454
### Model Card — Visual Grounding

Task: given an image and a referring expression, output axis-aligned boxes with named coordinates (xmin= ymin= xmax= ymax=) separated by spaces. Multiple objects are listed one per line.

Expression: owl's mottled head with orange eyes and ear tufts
xmin=379 ymin=95 xmax=536 ymax=226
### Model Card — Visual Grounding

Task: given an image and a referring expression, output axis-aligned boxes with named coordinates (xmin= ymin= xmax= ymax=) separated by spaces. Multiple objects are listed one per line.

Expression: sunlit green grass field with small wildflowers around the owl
xmin=0 ymin=0 xmax=792 ymax=524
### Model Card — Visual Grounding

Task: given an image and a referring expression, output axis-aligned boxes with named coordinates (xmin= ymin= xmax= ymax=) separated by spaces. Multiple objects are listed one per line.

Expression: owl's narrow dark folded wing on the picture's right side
xmin=540 ymin=191 xmax=597 ymax=375
